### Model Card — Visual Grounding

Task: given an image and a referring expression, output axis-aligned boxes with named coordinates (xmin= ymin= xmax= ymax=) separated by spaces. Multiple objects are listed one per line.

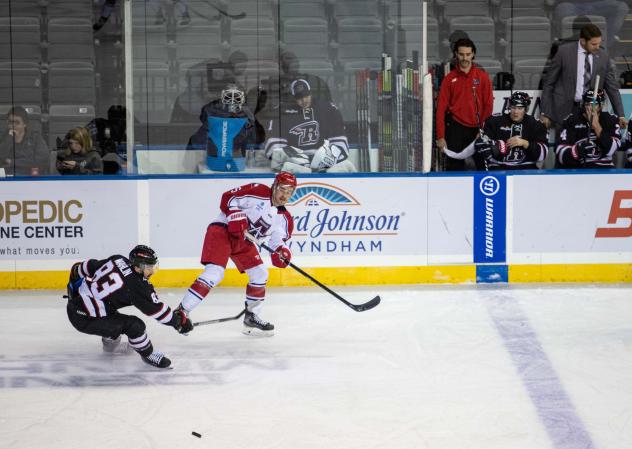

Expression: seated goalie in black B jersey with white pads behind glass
xmin=265 ymin=78 xmax=357 ymax=173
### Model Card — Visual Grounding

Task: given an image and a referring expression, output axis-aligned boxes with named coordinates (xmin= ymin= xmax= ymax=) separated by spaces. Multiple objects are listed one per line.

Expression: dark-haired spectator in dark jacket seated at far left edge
xmin=0 ymin=106 xmax=50 ymax=176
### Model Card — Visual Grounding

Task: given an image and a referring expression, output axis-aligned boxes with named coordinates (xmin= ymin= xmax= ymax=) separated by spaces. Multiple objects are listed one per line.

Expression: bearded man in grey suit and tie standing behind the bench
xmin=540 ymin=24 xmax=627 ymax=131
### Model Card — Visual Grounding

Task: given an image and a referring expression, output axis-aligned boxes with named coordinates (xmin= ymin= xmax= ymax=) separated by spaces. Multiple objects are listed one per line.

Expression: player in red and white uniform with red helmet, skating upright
xmin=178 ymin=172 xmax=296 ymax=335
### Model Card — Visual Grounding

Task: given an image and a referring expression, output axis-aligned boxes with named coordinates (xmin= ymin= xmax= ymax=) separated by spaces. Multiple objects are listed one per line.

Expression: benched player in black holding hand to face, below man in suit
xmin=555 ymin=89 xmax=621 ymax=168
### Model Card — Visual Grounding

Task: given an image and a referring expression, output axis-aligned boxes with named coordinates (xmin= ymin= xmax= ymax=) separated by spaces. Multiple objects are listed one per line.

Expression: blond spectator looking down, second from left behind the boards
xmin=57 ymin=127 xmax=103 ymax=175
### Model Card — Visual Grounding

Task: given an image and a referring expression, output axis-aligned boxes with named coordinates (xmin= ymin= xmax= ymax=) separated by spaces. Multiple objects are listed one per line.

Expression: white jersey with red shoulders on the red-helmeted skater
xmin=214 ymin=183 xmax=294 ymax=249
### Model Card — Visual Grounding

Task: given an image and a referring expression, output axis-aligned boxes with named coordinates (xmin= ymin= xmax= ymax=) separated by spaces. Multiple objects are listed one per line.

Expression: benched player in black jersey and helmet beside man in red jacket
xmin=474 ymin=92 xmax=548 ymax=170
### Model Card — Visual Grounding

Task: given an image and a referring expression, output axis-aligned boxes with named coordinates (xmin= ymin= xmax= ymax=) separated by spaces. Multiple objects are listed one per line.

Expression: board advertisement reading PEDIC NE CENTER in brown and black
xmin=0 ymin=180 xmax=138 ymax=267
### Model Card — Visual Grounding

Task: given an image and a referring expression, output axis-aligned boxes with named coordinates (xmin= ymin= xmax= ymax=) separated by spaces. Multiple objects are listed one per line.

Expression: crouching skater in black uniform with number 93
xmin=67 ymin=245 xmax=193 ymax=368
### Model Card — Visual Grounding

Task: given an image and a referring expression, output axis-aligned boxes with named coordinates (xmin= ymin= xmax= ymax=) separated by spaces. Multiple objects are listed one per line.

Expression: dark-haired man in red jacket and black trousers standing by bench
xmin=436 ymin=39 xmax=494 ymax=171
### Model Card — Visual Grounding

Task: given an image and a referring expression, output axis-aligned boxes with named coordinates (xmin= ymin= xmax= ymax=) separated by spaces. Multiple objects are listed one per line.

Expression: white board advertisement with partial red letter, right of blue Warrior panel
xmin=509 ymin=173 xmax=632 ymax=263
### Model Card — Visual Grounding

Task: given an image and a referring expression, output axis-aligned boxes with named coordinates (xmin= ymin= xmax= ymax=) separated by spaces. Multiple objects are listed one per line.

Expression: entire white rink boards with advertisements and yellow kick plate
xmin=0 ymin=171 xmax=632 ymax=289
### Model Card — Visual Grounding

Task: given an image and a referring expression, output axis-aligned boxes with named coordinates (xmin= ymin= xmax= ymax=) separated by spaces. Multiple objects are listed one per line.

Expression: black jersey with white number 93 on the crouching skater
xmin=71 ymin=255 xmax=173 ymax=324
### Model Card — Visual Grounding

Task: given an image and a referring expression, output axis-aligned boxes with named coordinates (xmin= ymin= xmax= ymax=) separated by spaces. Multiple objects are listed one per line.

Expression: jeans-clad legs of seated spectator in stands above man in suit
xmin=553 ymin=0 xmax=630 ymax=51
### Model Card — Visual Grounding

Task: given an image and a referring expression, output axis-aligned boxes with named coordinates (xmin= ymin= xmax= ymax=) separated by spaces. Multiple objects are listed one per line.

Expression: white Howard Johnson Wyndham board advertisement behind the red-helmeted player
xmin=149 ymin=178 xmax=434 ymax=264
